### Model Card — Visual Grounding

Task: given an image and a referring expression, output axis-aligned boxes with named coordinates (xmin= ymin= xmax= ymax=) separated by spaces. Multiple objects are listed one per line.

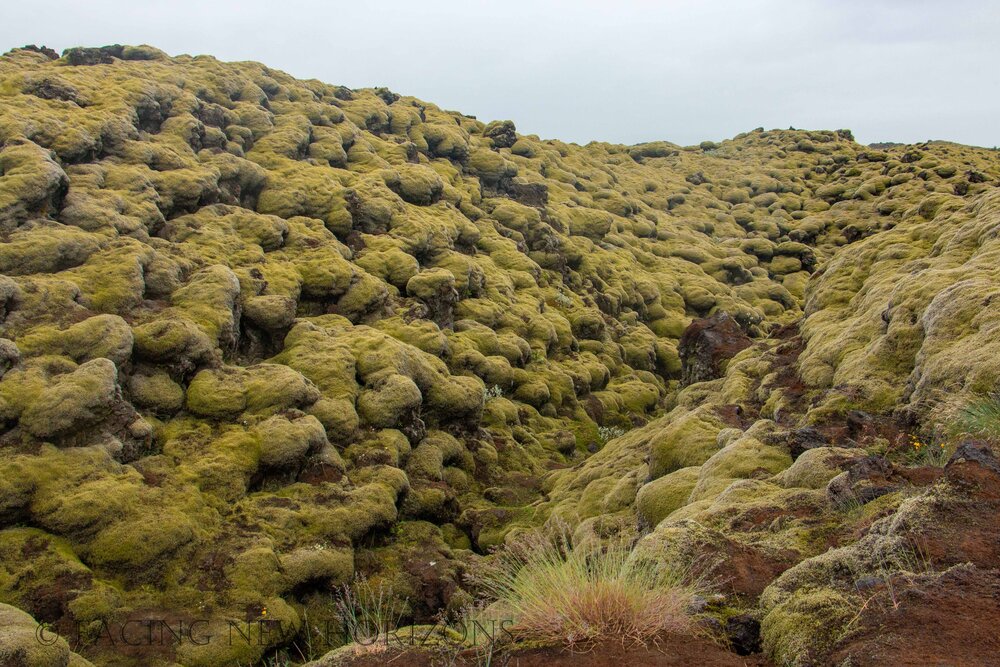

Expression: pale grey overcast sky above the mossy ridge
xmin=0 ymin=0 xmax=1000 ymax=146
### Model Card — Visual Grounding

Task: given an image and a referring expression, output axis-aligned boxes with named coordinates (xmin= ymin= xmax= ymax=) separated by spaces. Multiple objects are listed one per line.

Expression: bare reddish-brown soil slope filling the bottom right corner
xmin=829 ymin=442 xmax=1000 ymax=667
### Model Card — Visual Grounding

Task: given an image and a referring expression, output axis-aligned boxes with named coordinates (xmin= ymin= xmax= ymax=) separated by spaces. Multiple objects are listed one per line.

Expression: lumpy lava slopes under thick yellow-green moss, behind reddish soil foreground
xmin=0 ymin=41 xmax=1000 ymax=666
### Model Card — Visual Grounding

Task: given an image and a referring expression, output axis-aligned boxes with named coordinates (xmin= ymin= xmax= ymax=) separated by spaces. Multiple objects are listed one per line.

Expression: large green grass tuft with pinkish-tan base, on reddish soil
xmin=476 ymin=533 xmax=697 ymax=647
